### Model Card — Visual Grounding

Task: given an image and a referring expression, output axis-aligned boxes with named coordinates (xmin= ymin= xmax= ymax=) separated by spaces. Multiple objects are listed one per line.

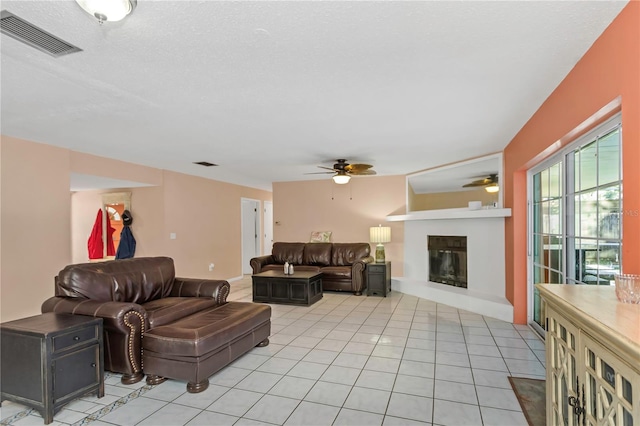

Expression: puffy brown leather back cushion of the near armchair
xmin=56 ymin=257 xmax=175 ymax=304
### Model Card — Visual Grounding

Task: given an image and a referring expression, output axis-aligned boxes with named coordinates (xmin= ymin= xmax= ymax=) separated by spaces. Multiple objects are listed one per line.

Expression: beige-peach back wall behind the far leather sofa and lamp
xmin=273 ymin=176 xmax=406 ymax=277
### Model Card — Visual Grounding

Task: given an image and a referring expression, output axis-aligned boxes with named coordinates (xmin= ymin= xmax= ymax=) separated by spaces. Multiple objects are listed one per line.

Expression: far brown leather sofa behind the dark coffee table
xmin=250 ymin=242 xmax=374 ymax=296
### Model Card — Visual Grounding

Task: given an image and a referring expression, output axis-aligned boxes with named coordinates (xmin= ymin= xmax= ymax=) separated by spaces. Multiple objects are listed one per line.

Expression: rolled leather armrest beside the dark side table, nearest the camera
xmin=41 ymin=296 xmax=148 ymax=383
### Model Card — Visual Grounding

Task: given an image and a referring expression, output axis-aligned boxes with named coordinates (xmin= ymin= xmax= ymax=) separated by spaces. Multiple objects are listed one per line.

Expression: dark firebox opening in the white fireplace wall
xmin=427 ymin=235 xmax=467 ymax=288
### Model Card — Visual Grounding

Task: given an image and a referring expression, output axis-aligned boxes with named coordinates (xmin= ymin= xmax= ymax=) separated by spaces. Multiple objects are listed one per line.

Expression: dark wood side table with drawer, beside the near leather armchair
xmin=0 ymin=313 xmax=104 ymax=424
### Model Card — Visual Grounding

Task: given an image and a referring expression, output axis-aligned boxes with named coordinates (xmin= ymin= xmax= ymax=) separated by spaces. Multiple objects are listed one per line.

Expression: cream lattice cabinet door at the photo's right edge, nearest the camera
xmin=580 ymin=332 xmax=640 ymax=426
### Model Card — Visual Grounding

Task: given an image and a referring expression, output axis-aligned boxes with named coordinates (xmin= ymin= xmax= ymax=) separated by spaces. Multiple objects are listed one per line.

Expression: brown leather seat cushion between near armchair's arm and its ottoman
xmin=142 ymin=297 xmax=217 ymax=328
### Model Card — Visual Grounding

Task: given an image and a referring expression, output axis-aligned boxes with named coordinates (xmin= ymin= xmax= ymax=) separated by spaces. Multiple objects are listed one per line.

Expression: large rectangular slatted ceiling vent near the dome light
xmin=0 ymin=10 xmax=82 ymax=57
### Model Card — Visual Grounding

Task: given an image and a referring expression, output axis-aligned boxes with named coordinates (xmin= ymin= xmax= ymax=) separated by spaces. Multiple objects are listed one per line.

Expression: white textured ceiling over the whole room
xmin=0 ymin=0 xmax=626 ymax=190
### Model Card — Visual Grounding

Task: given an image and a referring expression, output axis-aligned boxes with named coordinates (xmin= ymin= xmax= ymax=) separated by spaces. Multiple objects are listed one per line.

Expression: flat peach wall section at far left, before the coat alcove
xmin=0 ymin=136 xmax=71 ymax=322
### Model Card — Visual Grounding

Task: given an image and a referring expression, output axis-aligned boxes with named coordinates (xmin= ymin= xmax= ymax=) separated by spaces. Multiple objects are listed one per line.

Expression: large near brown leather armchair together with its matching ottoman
xmin=42 ymin=257 xmax=271 ymax=392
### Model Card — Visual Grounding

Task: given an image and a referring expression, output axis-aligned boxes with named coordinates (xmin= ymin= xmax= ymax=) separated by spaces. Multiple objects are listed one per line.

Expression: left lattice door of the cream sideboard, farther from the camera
xmin=547 ymin=308 xmax=579 ymax=426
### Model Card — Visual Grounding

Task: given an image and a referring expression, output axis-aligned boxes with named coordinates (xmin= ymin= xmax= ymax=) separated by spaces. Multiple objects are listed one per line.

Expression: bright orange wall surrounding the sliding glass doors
xmin=503 ymin=1 xmax=640 ymax=324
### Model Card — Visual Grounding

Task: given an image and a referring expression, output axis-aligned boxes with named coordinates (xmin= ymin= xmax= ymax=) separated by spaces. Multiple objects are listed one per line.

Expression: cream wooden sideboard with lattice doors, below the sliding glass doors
xmin=536 ymin=284 xmax=640 ymax=426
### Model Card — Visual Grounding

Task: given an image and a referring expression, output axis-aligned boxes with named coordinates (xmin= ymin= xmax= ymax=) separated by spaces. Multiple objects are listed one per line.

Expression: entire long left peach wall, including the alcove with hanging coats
xmin=0 ymin=136 xmax=272 ymax=321
